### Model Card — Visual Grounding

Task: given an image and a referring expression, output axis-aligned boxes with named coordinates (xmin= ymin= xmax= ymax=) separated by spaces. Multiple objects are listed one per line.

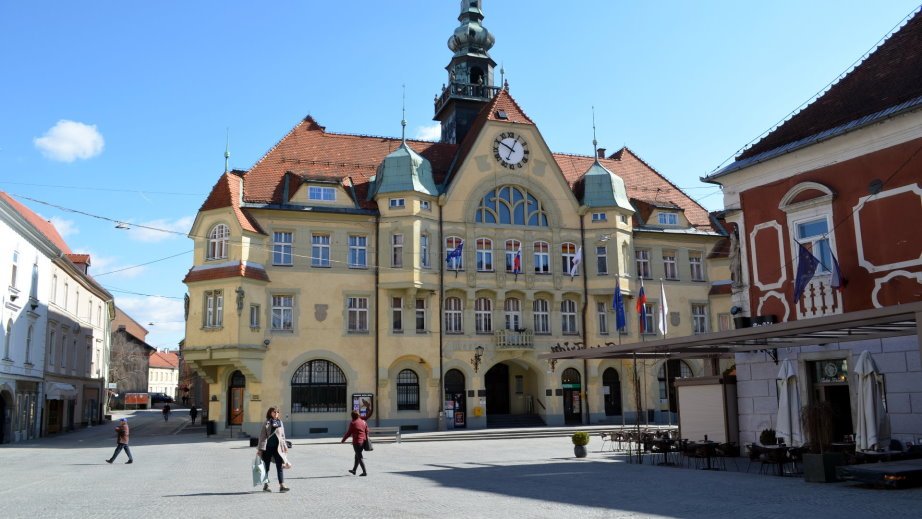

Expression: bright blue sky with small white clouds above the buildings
xmin=0 ymin=0 xmax=918 ymax=348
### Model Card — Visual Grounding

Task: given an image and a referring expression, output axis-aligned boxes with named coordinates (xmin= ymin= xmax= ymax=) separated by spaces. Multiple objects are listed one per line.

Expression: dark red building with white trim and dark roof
xmin=705 ymin=11 xmax=922 ymax=447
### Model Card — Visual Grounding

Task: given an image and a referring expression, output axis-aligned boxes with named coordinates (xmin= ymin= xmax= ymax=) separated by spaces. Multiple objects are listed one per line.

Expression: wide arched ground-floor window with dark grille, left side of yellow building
xmin=291 ymin=360 xmax=346 ymax=413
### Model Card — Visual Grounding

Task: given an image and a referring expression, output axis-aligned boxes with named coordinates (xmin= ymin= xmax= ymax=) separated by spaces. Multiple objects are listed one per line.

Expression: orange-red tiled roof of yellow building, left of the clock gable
xmin=244 ymin=116 xmax=456 ymax=209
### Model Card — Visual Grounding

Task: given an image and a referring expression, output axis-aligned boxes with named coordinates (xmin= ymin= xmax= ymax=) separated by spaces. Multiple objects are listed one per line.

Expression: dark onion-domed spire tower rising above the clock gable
xmin=433 ymin=0 xmax=501 ymax=144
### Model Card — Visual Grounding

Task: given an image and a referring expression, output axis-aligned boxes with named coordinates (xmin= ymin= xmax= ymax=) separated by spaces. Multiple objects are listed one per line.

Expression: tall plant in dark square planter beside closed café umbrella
xmin=801 ymin=402 xmax=845 ymax=483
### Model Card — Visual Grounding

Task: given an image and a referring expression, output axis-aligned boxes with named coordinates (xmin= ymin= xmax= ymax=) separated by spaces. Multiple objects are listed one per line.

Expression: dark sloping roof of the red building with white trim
xmin=736 ymin=11 xmax=922 ymax=161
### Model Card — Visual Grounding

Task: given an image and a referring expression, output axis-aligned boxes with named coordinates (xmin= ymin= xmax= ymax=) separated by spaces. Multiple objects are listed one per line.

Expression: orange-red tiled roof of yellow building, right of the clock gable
xmin=554 ymin=147 xmax=711 ymax=228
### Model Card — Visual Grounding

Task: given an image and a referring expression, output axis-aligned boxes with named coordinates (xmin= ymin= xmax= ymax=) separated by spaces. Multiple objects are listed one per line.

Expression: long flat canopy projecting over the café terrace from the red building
xmin=540 ymin=303 xmax=922 ymax=360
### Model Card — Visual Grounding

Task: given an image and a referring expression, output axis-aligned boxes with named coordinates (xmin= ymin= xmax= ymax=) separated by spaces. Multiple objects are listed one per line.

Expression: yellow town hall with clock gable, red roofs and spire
xmin=183 ymin=1 xmax=729 ymax=436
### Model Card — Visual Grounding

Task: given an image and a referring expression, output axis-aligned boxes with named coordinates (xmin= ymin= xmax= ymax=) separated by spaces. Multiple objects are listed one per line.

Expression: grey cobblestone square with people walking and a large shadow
xmin=0 ymin=409 xmax=922 ymax=519
